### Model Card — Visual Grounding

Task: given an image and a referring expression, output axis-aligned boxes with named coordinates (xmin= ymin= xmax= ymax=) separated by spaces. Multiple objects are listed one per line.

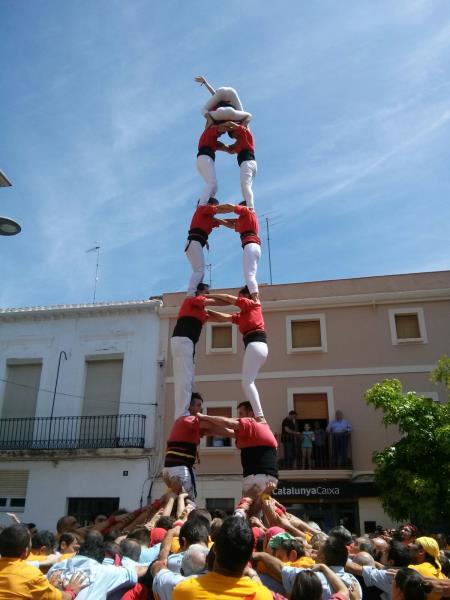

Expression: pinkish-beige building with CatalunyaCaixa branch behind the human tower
xmin=155 ymin=271 xmax=450 ymax=532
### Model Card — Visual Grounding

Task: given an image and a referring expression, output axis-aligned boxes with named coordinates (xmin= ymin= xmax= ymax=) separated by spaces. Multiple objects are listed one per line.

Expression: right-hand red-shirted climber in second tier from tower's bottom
xmin=206 ymin=286 xmax=269 ymax=420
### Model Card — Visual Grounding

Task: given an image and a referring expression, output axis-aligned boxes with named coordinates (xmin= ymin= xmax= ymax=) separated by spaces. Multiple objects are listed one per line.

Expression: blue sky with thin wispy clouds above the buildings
xmin=0 ymin=0 xmax=450 ymax=307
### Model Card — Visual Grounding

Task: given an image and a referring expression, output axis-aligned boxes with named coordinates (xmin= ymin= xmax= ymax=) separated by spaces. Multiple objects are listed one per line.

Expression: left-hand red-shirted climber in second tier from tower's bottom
xmin=170 ymin=283 xmax=224 ymax=419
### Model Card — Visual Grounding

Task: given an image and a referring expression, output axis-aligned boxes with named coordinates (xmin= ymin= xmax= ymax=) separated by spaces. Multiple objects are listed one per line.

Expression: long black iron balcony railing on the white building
xmin=0 ymin=415 xmax=146 ymax=450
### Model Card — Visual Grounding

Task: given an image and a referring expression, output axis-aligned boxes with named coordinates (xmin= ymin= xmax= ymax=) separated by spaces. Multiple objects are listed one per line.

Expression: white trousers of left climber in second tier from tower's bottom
xmin=170 ymin=336 xmax=195 ymax=420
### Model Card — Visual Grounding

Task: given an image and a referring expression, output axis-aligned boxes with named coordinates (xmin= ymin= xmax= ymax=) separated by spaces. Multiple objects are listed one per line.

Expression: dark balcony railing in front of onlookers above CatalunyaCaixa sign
xmin=277 ymin=433 xmax=353 ymax=470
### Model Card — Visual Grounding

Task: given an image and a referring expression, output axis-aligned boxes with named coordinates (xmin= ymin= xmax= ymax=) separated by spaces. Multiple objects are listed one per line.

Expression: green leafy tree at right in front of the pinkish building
xmin=365 ymin=357 xmax=450 ymax=526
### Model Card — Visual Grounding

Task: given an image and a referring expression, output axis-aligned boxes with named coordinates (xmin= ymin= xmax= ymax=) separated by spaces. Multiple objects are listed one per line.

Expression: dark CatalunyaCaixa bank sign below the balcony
xmin=273 ymin=481 xmax=377 ymax=500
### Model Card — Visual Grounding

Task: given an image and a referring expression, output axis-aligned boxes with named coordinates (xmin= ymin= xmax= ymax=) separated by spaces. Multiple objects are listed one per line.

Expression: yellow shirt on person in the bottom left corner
xmin=0 ymin=557 xmax=62 ymax=600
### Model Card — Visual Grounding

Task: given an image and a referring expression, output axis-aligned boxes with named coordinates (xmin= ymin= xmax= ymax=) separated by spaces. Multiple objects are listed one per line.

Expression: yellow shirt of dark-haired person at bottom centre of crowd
xmin=172 ymin=572 xmax=272 ymax=600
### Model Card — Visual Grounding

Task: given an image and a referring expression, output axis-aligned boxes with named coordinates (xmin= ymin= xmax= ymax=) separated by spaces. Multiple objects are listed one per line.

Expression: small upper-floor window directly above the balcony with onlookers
xmin=286 ymin=314 xmax=327 ymax=354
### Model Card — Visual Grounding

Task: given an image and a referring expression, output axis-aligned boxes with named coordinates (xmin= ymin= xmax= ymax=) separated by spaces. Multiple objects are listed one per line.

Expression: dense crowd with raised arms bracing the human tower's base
xmin=0 ymin=493 xmax=450 ymax=600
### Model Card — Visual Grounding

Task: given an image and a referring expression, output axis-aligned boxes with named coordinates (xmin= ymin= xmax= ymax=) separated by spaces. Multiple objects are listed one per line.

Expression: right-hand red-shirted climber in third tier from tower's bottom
xmin=217 ymin=200 xmax=261 ymax=301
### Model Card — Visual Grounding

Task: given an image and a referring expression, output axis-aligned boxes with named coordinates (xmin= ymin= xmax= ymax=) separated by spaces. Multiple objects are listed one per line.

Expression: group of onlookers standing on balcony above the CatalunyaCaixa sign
xmin=281 ymin=410 xmax=352 ymax=469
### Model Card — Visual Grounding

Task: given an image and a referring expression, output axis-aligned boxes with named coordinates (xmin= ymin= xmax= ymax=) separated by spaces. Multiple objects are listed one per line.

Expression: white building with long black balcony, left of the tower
xmin=0 ymin=300 xmax=162 ymax=529
